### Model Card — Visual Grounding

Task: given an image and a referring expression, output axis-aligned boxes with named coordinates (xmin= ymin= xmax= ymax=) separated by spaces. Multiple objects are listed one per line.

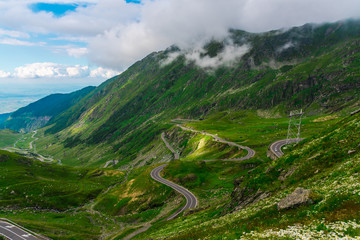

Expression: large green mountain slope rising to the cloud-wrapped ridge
xmin=31 ymin=21 xmax=360 ymax=165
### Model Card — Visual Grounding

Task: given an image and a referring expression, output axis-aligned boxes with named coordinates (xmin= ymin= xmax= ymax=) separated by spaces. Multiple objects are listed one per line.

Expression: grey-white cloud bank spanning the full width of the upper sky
xmin=0 ymin=0 xmax=360 ymax=71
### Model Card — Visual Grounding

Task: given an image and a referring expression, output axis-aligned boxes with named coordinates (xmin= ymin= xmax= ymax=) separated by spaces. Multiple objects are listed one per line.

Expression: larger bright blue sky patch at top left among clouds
xmin=30 ymin=2 xmax=87 ymax=17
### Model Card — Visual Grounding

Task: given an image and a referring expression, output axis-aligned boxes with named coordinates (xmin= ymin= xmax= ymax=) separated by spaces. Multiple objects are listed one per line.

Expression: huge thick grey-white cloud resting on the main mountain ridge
xmin=83 ymin=0 xmax=360 ymax=69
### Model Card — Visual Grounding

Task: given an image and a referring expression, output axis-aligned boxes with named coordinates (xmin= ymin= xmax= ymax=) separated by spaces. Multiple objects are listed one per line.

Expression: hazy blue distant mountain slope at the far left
xmin=0 ymin=87 xmax=95 ymax=132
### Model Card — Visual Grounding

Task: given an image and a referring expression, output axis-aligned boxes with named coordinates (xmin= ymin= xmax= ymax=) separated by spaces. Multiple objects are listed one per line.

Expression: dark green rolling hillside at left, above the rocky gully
xmin=0 ymin=151 xmax=123 ymax=210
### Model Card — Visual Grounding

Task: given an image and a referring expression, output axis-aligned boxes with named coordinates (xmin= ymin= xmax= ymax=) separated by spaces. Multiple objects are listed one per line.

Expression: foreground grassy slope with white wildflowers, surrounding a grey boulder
xmin=135 ymin=109 xmax=360 ymax=239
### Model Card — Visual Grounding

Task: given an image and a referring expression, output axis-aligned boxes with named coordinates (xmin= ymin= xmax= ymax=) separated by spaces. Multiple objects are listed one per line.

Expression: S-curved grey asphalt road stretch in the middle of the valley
xmin=150 ymin=164 xmax=198 ymax=220
